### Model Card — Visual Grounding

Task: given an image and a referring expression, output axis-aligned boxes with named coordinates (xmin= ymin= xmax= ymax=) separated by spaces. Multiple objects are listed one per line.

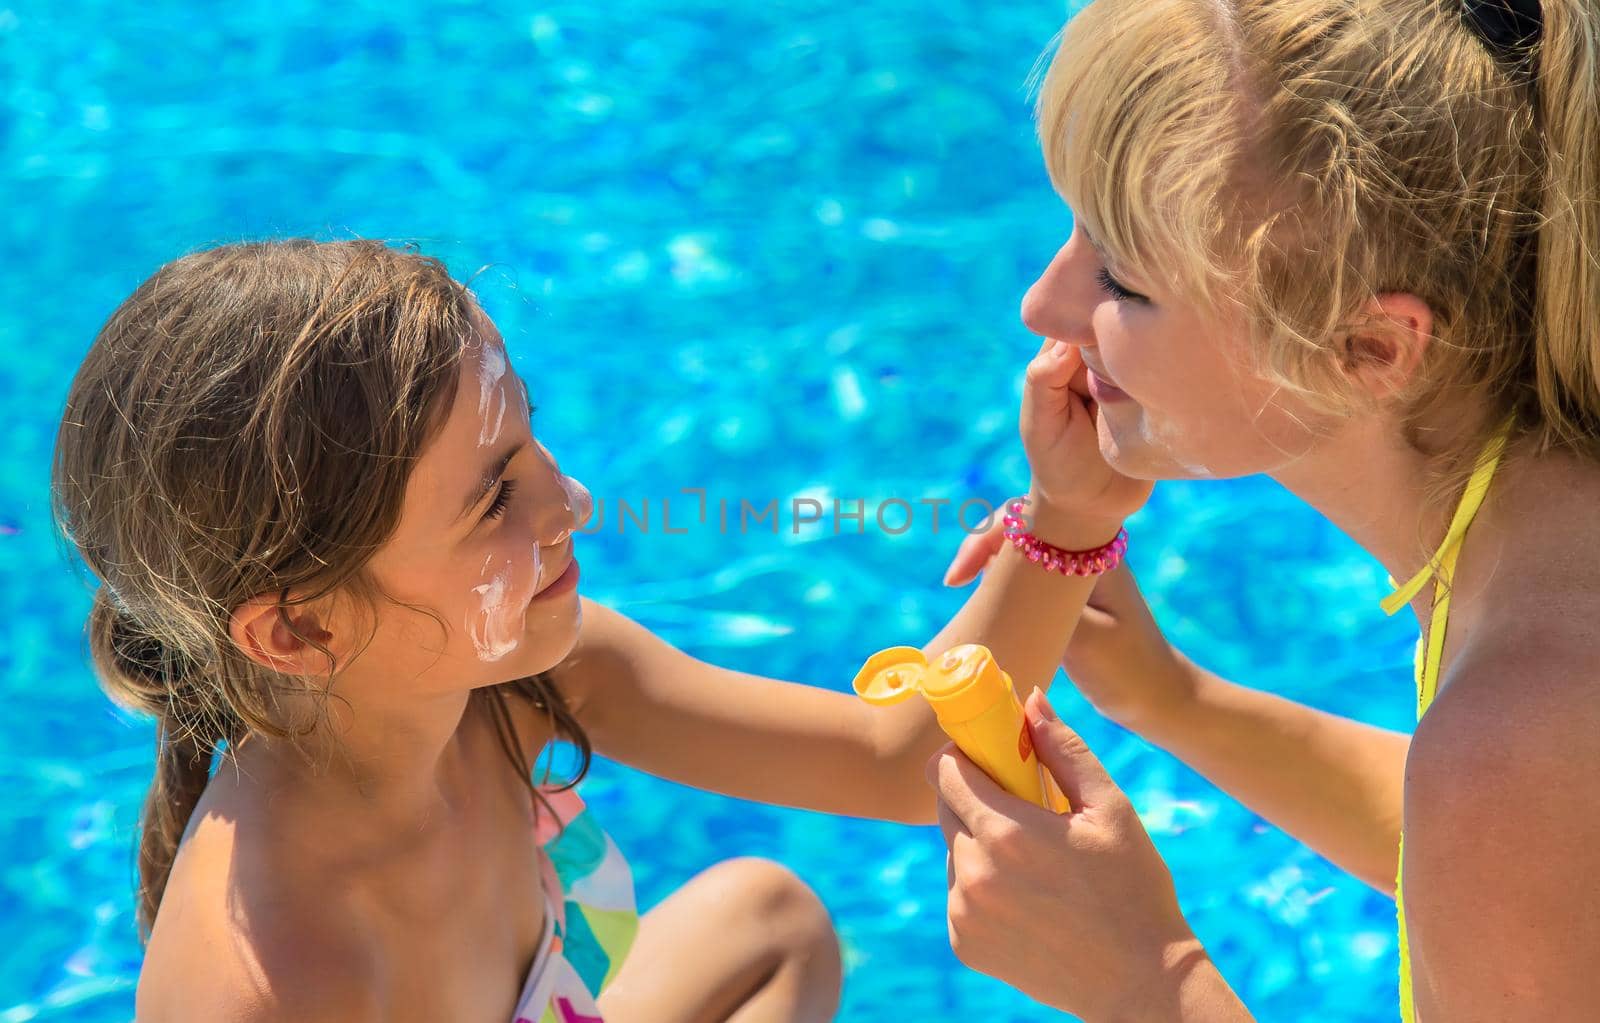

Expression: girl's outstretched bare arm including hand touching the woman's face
xmin=558 ymin=341 xmax=1150 ymax=823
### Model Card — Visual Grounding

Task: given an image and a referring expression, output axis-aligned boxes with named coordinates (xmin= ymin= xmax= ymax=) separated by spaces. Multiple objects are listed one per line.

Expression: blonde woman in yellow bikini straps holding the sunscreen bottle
xmin=933 ymin=0 xmax=1600 ymax=1023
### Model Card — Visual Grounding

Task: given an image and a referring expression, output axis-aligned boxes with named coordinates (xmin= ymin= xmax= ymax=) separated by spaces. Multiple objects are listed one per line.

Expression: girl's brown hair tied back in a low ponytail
xmin=53 ymin=240 xmax=589 ymax=933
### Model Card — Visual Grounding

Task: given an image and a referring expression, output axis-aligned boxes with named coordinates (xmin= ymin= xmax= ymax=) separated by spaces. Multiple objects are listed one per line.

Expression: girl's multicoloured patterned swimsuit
xmin=512 ymin=789 xmax=638 ymax=1023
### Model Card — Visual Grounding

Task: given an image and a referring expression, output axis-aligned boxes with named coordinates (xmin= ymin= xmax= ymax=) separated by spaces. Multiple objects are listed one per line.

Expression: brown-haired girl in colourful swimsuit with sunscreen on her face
xmin=54 ymin=242 xmax=1147 ymax=1023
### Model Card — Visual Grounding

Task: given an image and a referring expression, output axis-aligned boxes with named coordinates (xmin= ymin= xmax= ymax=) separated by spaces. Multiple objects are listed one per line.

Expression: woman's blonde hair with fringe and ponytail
xmin=1038 ymin=0 xmax=1600 ymax=488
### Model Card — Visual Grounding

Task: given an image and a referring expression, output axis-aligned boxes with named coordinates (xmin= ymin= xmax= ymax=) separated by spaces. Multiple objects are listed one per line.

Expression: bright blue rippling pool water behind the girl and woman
xmin=0 ymin=0 xmax=1414 ymax=1023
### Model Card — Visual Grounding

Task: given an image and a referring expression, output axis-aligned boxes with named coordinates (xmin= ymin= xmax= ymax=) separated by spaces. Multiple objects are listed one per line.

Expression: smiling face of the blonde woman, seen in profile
xmin=1022 ymin=223 xmax=1318 ymax=479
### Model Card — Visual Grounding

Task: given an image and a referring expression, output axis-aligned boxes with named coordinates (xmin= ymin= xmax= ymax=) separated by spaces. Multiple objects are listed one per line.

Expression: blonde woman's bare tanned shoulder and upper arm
xmin=1402 ymin=592 xmax=1600 ymax=998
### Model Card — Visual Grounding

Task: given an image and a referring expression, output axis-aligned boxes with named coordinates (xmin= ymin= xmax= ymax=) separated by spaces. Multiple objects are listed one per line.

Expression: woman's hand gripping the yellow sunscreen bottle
xmin=928 ymin=690 xmax=1237 ymax=1023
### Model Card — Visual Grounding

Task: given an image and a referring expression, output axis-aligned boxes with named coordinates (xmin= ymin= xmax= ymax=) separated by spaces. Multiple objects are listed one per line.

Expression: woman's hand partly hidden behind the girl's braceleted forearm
xmin=944 ymin=524 xmax=1195 ymax=732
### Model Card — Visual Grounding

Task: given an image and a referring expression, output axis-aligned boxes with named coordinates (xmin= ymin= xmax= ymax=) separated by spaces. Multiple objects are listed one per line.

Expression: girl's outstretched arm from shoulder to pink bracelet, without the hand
xmin=557 ymin=503 xmax=1117 ymax=823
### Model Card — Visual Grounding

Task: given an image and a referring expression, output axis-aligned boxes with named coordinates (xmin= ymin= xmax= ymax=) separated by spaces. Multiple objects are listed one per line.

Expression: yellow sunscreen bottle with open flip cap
xmin=854 ymin=644 xmax=1070 ymax=813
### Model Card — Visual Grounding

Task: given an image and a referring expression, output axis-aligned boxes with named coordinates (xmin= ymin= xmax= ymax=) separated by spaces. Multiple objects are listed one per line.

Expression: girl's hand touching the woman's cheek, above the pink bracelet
xmin=1022 ymin=339 xmax=1154 ymax=522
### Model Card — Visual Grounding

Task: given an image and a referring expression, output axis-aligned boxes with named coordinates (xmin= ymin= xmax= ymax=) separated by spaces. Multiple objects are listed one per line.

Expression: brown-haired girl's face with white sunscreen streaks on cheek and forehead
xmin=347 ymin=314 xmax=590 ymax=692
